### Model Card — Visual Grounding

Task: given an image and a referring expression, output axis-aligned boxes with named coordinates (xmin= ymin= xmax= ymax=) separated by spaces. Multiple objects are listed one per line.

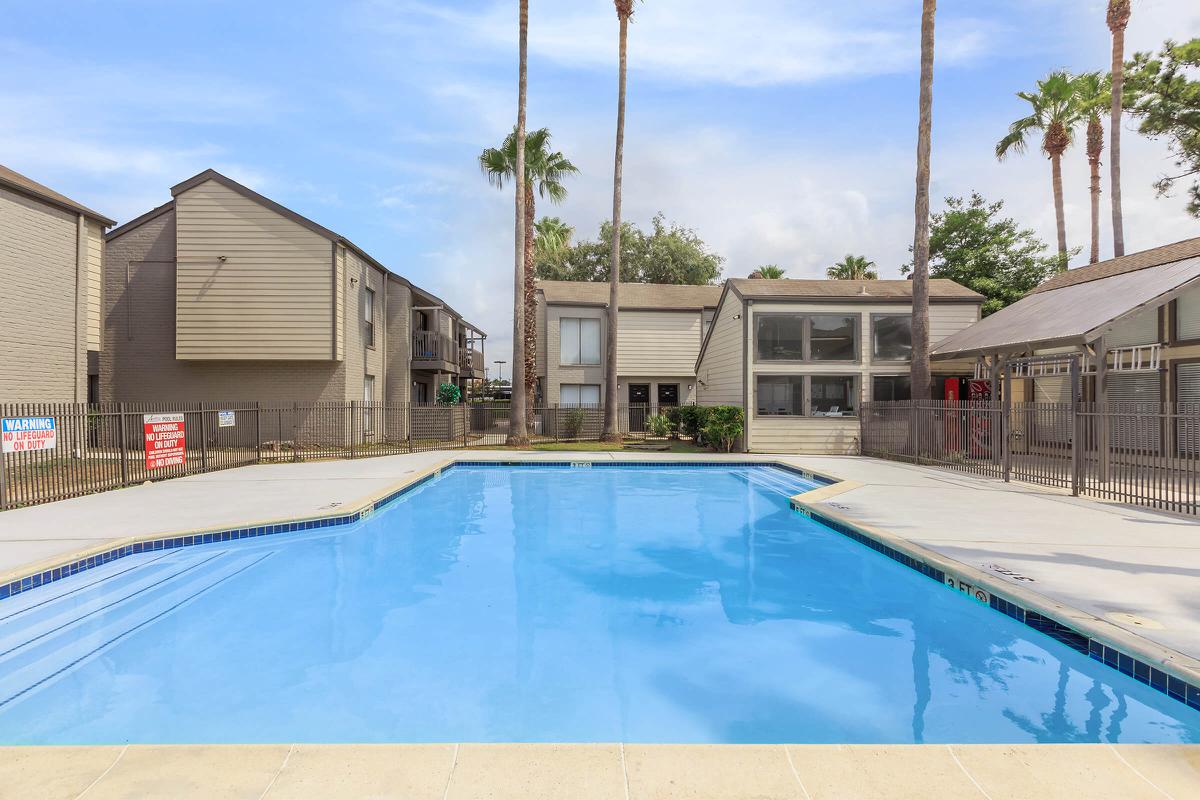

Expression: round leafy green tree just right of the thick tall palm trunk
xmin=900 ymin=192 xmax=1070 ymax=317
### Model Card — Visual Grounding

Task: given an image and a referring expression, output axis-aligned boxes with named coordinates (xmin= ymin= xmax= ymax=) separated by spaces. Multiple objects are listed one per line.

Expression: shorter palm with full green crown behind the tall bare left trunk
xmin=479 ymin=128 xmax=580 ymax=426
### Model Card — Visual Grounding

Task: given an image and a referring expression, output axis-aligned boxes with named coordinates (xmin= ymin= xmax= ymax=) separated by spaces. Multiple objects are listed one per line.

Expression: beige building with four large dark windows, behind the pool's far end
xmin=695 ymin=278 xmax=983 ymax=453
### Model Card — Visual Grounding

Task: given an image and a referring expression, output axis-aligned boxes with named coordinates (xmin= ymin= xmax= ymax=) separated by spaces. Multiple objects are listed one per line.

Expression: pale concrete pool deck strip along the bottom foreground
xmin=0 ymin=744 xmax=1200 ymax=800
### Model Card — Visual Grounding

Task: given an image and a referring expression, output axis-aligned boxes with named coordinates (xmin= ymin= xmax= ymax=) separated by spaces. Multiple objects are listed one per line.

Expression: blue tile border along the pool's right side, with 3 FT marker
xmin=792 ymin=503 xmax=1200 ymax=711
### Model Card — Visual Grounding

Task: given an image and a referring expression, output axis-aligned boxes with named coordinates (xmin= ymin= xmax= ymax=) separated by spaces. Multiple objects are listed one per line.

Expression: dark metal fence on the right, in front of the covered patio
xmin=862 ymin=401 xmax=1200 ymax=515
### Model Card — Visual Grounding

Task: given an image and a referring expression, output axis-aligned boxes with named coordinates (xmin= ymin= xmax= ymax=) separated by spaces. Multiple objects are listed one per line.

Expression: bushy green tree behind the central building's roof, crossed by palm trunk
xmin=538 ymin=213 xmax=725 ymax=284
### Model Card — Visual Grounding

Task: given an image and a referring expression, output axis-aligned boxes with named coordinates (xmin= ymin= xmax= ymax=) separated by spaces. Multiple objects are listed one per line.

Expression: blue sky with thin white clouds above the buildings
xmin=0 ymin=0 xmax=1200 ymax=361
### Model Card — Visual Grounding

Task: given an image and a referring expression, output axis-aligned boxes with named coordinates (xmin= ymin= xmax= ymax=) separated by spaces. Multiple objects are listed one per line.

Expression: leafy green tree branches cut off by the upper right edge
xmin=1126 ymin=38 xmax=1200 ymax=217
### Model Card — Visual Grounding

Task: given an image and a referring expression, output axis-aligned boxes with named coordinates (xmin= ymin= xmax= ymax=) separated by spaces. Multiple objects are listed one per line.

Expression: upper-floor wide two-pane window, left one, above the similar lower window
xmin=755 ymin=314 xmax=859 ymax=361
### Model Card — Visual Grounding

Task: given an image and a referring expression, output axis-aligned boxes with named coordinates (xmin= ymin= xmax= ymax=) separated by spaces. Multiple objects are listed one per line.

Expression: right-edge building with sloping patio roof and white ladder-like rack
xmin=934 ymin=237 xmax=1200 ymax=431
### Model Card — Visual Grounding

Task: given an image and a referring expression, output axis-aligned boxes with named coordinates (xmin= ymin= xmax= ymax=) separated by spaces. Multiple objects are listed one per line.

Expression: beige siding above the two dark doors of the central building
xmin=617 ymin=311 xmax=700 ymax=375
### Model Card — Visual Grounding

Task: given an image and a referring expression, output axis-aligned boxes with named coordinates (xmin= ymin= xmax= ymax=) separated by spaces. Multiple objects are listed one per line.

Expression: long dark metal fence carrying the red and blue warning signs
xmin=0 ymin=402 xmax=696 ymax=510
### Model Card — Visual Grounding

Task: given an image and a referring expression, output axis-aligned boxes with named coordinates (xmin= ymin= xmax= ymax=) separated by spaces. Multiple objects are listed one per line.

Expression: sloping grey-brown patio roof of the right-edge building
xmin=932 ymin=253 xmax=1200 ymax=359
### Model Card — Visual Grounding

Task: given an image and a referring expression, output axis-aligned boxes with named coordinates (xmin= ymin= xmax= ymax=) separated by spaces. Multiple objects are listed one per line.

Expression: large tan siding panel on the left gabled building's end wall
xmin=175 ymin=180 xmax=336 ymax=361
